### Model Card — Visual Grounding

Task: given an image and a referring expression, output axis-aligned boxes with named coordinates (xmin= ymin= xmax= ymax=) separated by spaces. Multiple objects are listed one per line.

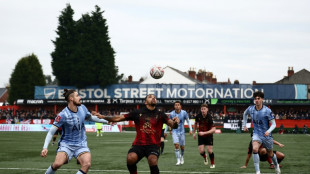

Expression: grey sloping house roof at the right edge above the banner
xmin=275 ymin=69 xmax=310 ymax=84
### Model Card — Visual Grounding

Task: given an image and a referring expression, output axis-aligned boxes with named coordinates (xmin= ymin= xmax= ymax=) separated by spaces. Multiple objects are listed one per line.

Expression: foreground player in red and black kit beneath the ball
xmin=92 ymin=94 xmax=179 ymax=174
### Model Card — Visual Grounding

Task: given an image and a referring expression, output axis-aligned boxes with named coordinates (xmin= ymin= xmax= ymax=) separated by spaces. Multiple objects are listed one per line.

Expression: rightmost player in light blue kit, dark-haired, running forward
xmin=243 ymin=91 xmax=281 ymax=174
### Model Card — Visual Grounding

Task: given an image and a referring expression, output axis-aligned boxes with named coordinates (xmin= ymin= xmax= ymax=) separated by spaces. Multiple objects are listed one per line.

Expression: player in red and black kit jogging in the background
xmin=193 ymin=104 xmax=216 ymax=168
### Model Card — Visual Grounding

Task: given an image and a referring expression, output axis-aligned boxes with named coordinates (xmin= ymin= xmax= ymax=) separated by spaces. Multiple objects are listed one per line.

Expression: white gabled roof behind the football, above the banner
xmin=141 ymin=66 xmax=201 ymax=84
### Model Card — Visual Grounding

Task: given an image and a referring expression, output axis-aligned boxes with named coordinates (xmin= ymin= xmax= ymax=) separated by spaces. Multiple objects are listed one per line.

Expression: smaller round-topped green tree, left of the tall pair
xmin=8 ymin=54 xmax=46 ymax=104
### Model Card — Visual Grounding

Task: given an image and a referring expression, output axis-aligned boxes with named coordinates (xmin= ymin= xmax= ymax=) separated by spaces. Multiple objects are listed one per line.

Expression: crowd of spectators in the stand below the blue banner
xmin=0 ymin=106 xmax=310 ymax=123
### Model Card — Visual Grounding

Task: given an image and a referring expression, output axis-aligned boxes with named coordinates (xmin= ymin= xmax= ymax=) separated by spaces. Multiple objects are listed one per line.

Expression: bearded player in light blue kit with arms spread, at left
xmin=41 ymin=89 xmax=107 ymax=174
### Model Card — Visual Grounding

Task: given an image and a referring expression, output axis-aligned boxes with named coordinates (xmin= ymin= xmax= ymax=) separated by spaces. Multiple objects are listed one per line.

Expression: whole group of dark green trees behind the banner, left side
xmin=8 ymin=4 xmax=123 ymax=104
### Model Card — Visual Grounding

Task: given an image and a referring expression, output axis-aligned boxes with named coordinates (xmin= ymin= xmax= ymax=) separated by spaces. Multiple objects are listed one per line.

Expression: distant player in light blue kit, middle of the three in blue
xmin=166 ymin=101 xmax=193 ymax=166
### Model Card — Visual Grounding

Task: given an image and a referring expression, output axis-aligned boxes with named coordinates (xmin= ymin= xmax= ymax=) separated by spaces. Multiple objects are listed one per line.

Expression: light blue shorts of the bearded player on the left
xmin=57 ymin=146 xmax=90 ymax=162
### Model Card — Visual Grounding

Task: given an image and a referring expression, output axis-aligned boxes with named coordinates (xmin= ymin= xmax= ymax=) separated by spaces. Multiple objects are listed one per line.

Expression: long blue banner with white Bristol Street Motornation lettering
xmin=34 ymin=84 xmax=307 ymax=100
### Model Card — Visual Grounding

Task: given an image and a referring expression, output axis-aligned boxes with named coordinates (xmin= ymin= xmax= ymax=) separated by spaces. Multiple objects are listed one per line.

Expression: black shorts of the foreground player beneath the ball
xmin=128 ymin=145 xmax=160 ymax=161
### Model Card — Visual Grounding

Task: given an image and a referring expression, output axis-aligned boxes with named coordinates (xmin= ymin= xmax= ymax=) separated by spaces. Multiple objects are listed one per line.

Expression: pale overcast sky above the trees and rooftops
xmin=0 ymin=0 xmax=310 ymax=87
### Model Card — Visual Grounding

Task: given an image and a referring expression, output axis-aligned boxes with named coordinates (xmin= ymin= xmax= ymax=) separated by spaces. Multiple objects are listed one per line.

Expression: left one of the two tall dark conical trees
xmin=51 ymin=4 xmax=78 ymax=85
